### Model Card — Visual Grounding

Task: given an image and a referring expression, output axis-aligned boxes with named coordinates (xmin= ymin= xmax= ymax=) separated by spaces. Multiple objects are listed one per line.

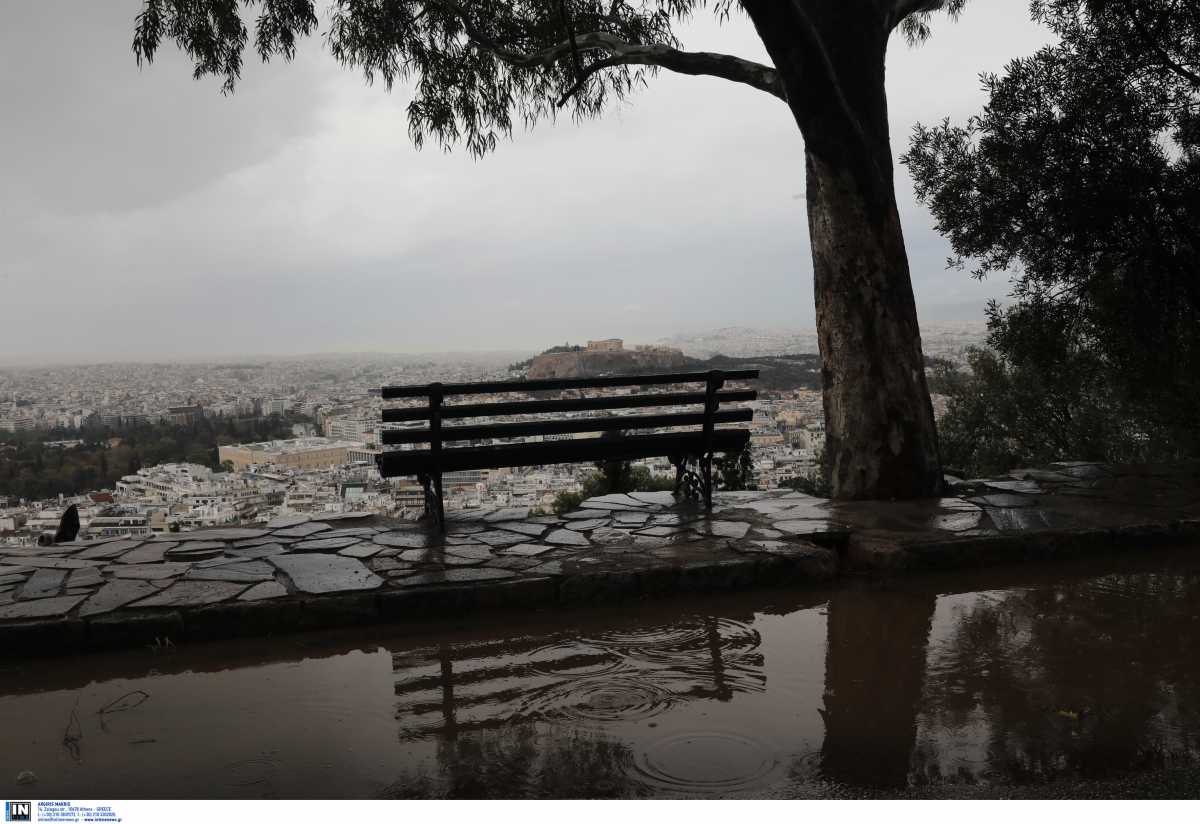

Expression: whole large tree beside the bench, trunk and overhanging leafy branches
xmin=133 ymin=0 xmax=966 ymax=498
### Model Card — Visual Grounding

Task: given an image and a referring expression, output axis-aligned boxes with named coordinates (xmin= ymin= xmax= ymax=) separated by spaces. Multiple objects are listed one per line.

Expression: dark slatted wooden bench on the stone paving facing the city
xmin=377 ymin=369 xmax=758 ymax=528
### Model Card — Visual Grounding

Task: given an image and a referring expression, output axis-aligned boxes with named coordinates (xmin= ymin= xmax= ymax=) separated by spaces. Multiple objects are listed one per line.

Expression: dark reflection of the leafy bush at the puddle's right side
xmin=913 ymin=572 xmax=1200 ymax=783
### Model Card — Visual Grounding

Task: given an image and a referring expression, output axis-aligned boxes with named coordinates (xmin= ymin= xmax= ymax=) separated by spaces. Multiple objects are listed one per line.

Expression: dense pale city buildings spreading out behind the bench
xmin=0 ymin=330 xmax=974 ymax=545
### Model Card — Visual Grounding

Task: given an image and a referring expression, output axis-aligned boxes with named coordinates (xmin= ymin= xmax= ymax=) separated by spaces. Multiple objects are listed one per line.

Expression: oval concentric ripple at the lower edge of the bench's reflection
xmin=521 ymin=678 xmax=676 ymax=723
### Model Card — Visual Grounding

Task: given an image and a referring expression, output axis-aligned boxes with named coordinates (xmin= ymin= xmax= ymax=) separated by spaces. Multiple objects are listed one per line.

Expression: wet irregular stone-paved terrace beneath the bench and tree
xmin=0 ymin=463 xmax=1200 ymax=655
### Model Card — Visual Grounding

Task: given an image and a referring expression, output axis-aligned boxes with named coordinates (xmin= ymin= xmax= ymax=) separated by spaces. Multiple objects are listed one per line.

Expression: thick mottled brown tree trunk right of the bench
xmin=744 ymin=0 xmax=942 ymax=499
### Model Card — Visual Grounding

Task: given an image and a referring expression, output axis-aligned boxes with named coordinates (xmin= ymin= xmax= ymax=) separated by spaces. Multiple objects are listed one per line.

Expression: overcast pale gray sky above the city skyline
xmin=0 ymin=0 xmax=1046 ymax=362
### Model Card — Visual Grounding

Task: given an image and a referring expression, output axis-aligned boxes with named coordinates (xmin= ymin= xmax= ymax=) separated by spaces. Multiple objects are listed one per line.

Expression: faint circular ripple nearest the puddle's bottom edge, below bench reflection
xmin=631 ymin=732 xmax=781 ymax=795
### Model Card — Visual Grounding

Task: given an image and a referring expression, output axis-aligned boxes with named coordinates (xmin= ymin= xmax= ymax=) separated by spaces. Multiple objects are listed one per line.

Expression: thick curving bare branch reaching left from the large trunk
xmin=431 ymin=0 xmax=787 ymax=106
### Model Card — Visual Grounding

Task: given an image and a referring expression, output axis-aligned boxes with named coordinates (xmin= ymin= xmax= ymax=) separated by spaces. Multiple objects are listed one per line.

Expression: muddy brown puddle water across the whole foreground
xmin=0 ymin=551 xmax=1200 ymax=798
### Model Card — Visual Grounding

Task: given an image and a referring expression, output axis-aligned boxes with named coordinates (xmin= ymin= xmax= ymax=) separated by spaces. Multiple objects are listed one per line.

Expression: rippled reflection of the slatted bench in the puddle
xmin=392 ymin=618 xmax=766 ymax=738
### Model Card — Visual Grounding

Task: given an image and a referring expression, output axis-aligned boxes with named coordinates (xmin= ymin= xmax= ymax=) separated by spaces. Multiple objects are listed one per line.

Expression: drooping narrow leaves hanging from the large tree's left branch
xmin=133 ymin=0 xmax=696 ymax=155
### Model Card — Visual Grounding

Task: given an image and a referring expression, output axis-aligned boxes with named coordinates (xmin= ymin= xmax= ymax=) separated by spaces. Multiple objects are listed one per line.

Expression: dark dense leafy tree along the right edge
xmin=904 ymin=0 xmax=1200 ymax=474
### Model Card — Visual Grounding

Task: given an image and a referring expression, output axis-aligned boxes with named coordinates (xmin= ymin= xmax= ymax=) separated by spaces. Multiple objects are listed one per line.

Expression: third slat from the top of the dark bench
xmin=383 ymin=409 xmax=754 ymax=445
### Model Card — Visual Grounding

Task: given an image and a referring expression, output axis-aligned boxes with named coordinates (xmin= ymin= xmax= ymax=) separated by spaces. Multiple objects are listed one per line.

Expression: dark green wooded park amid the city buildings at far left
xmin=0 ymin=416 xmax=294 ymax=500
